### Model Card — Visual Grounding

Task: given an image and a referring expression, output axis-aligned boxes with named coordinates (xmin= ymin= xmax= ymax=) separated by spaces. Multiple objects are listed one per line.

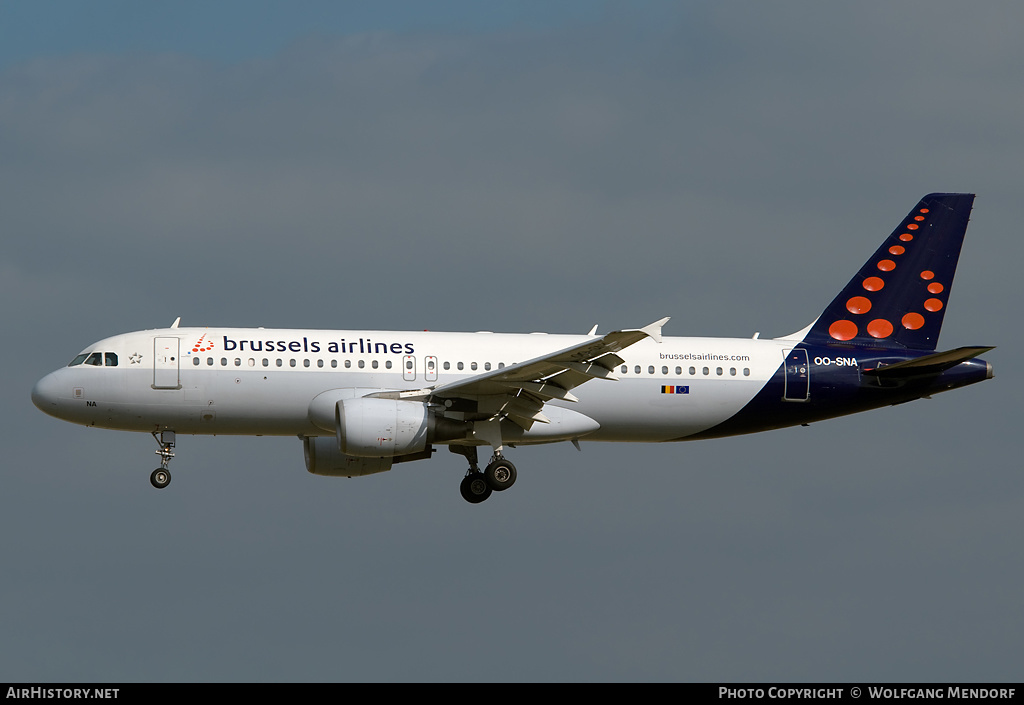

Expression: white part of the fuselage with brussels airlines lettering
xmin=34 ymin=328 xmax=782 ymax=443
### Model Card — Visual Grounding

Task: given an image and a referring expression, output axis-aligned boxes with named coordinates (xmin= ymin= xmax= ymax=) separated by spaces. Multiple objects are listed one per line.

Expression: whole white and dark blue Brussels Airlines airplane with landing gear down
xmin=32 ymin=194 xmax=993 ymax=504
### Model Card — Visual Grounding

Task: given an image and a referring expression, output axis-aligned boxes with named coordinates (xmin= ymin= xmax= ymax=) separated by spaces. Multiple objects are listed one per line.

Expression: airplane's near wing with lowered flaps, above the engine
xmin=385 ymin=318 xmax=669 ymax=430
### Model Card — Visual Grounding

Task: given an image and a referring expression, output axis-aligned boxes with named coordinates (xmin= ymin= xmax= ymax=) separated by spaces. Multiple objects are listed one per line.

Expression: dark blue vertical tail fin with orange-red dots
xmin=804 ymin=194 xmax=974 ymax=350
